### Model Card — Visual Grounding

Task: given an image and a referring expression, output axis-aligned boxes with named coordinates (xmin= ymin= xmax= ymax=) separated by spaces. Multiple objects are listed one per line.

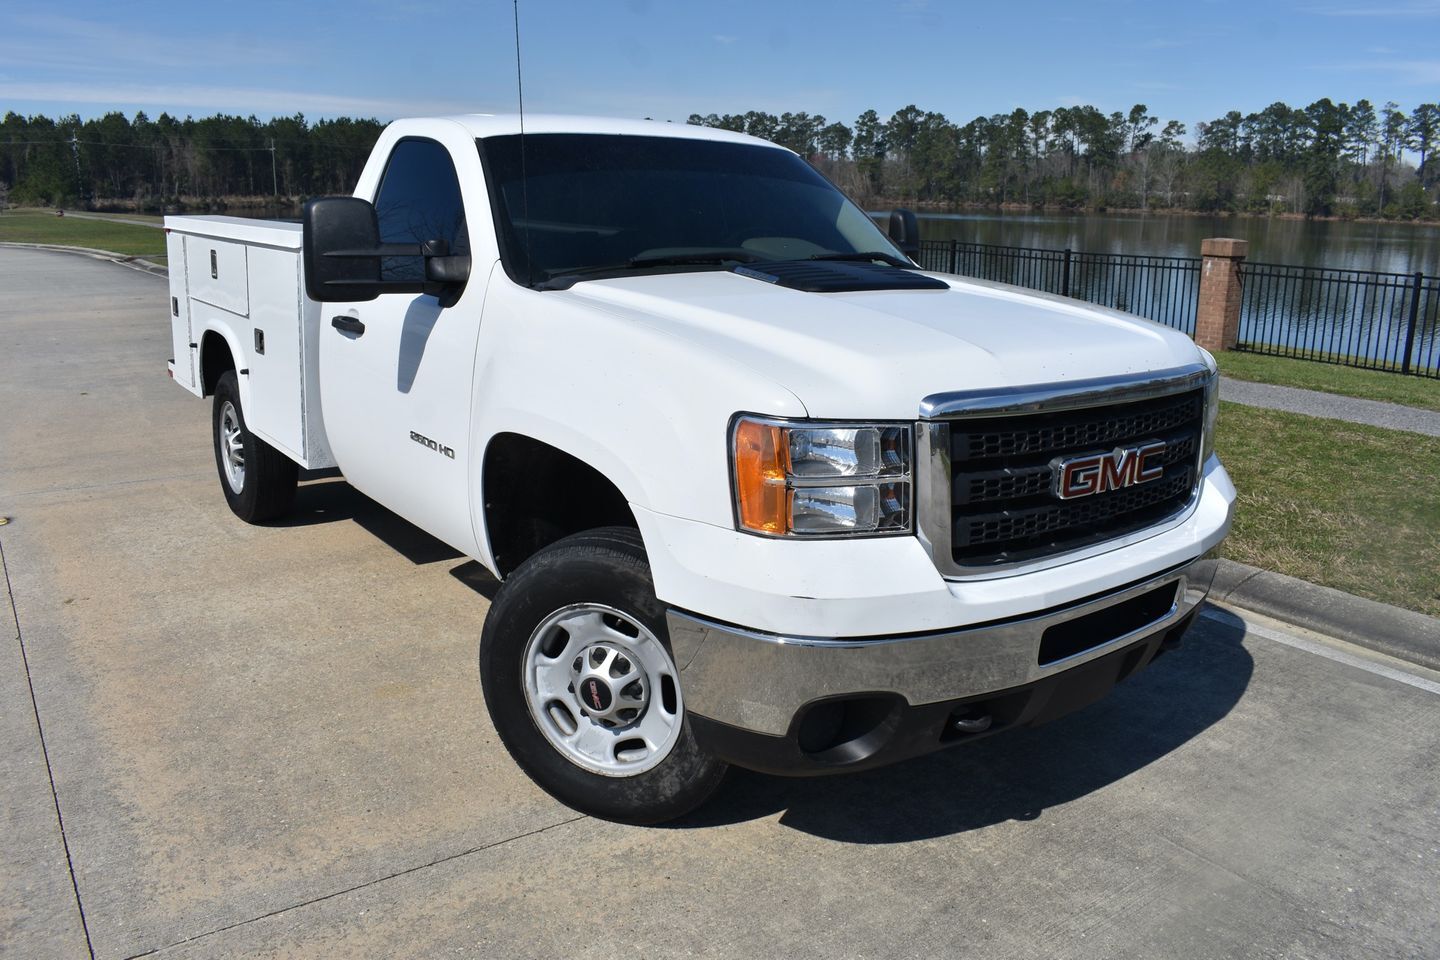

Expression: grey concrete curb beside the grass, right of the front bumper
xmin=1210 ymin=560 xmax=1440 ymax=669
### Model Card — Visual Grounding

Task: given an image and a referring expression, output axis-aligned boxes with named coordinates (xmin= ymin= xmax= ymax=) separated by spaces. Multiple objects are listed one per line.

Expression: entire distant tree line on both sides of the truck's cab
xmin=0 ymin=98 xmax=1440 ymax=217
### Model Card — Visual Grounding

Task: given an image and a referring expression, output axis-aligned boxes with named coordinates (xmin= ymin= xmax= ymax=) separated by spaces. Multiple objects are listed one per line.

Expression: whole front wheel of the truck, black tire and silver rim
xmin=480 ymin=527 xmax=726 ymax=823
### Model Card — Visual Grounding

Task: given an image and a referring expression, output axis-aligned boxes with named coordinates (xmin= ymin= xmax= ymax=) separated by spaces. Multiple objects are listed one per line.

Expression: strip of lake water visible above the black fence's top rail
xmin=876 ymin=212 xmax=1440 ymax=275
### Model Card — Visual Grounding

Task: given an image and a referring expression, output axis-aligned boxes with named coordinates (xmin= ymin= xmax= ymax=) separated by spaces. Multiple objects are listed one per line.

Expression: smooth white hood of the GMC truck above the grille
xmin=550 ymin=271 xmax=1200 ymax=420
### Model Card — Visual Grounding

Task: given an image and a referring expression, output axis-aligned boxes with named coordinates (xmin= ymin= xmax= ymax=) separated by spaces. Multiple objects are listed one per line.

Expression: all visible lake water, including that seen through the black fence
xmin=877 ymin=213 xmax=1440 ymax=376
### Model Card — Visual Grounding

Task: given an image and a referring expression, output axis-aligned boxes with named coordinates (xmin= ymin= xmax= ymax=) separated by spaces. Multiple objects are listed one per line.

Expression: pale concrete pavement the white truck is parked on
xmin=0 ymin=249 xmax=1440 ymax=960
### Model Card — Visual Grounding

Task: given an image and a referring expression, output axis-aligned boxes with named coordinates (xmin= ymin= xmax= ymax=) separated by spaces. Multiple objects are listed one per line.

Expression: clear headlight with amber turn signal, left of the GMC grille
xmin=730 ymin=417 xmax=912 ymax=537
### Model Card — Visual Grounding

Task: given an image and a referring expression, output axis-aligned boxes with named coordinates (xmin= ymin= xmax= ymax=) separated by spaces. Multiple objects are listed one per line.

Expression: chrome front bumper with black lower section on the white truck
xmin=668 ymin=560 xmax=1214 ymax=773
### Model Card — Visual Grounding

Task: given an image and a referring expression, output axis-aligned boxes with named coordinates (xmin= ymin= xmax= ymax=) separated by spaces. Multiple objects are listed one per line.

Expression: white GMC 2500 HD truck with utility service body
xmin=166 ymin=115 xmax=1234 ymax=822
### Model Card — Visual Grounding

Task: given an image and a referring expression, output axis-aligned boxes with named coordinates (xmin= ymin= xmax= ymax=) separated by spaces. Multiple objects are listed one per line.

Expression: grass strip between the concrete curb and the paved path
xmin=1217 ymin=403 xmax=1440 ymax=616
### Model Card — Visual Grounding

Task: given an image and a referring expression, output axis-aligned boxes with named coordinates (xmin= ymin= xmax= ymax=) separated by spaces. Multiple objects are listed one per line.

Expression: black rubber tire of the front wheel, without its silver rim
xmin=480 ymin=527 xmax=727 ymax=823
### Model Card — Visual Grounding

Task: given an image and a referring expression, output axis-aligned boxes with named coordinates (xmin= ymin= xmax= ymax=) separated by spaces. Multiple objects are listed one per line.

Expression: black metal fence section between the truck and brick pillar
xmin=920 ymin=240 xmax=1200 ymax=335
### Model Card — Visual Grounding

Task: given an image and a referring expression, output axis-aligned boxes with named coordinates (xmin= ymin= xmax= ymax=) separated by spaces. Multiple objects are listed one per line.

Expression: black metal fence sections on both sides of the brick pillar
xmin=919 ymin=240 xmax=1440 ymax=379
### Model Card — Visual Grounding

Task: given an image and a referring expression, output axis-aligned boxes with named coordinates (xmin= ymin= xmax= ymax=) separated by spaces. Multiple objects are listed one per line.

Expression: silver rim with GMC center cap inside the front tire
xmin=520 ymin=603 xmax=684 ymax=777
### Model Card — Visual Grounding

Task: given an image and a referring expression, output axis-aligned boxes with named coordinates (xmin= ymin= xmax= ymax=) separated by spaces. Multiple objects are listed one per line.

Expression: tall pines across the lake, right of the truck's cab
xmin=690 ymin=98 xmax=1440 ymax=219
